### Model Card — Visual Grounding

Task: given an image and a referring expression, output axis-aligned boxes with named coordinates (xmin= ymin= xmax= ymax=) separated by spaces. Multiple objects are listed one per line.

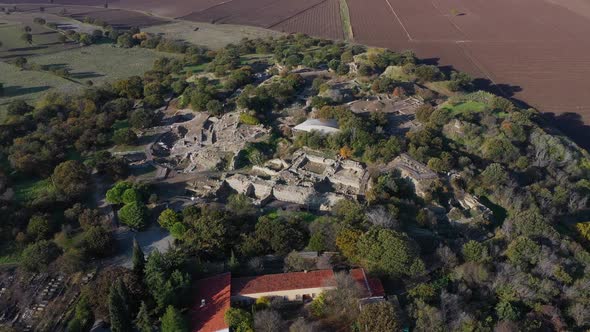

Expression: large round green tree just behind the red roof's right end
xmin=357 ymin=228 xmax=424 ymax=277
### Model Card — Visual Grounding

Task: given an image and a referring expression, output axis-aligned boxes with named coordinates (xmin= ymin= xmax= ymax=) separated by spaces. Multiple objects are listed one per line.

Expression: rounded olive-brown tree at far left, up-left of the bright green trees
xmin=51 ymin=160 xmax=90 ymax=198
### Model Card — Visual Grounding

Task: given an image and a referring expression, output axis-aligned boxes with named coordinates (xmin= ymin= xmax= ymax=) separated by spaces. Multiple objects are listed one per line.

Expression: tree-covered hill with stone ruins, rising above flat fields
xmin=0 ymin=21 xmax=590 ymax=331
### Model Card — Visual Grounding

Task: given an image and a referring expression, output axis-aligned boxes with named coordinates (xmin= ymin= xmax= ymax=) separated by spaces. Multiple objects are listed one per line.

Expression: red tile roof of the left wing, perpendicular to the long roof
xmin=190 ymin=273 xmax=231 ymax=332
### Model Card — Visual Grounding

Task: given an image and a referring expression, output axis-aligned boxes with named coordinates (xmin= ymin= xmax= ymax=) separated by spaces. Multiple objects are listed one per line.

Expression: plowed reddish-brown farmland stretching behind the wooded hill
xmin=0 ymin=0 xmax=590 ymax=147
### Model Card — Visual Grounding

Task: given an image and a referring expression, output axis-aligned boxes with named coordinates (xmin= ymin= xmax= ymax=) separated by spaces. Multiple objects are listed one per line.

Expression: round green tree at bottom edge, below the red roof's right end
xmin=356 ymin=301 xmax=402 ymax=332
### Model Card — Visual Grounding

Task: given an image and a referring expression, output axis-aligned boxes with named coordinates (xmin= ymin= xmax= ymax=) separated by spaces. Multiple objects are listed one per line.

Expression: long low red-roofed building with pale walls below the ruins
xmin=190 ymin=269 xmax=385 ymax=332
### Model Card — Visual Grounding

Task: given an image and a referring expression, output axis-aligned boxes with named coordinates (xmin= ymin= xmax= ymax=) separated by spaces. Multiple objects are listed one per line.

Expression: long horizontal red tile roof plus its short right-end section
xmin=231 ymin=269 xmax=385 ymax=297
